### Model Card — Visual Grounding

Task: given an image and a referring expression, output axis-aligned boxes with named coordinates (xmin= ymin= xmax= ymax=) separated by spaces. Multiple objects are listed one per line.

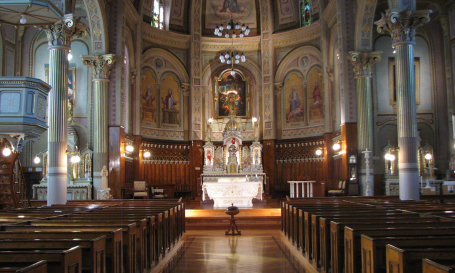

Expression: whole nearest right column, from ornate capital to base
xmin=376 ymin=9 xmax=431 ymax=201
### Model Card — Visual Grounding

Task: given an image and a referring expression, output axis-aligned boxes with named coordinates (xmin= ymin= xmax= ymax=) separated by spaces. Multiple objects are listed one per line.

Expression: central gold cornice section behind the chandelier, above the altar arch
xmin=201 ymin=36 xmax=261 ymax=52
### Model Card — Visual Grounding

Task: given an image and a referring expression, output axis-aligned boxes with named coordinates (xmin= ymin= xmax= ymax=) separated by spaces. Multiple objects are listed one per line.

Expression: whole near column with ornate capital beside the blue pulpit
xmin=45 ymin=14 xmax=86 ymax=206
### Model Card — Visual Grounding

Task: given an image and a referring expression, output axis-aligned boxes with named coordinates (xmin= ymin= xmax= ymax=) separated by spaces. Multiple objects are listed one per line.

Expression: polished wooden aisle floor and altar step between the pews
xmin=152 ymin=201 xmax=317 ymax=273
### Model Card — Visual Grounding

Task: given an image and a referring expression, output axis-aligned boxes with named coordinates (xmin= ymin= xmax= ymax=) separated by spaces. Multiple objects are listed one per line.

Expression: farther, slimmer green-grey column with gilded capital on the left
xmin=82 ymin=54 xmax=115 ymax=199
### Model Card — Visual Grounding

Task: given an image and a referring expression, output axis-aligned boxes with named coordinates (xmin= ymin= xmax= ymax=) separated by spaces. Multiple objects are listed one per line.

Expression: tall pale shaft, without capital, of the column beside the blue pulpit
xmin=47 ymin=46 xmax=69 ymax=206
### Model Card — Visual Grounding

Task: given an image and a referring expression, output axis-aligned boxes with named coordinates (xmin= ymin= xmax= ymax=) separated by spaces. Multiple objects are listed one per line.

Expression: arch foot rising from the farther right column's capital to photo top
xmin=354 ymin=0 xmax=377 ymax=51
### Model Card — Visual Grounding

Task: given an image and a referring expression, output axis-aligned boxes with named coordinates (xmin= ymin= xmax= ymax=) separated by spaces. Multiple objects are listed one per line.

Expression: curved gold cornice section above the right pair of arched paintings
xmin=272 ymin=21 xmax=321 ymax=48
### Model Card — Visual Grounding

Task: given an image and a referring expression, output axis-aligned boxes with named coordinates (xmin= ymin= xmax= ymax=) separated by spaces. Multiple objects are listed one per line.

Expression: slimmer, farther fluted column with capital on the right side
xmin=348 ymin=51 xmax=382 ymax=196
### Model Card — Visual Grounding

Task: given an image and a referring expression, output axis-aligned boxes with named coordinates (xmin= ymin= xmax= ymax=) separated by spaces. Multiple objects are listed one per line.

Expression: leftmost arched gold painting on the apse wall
xmin=141 ymin=70 xmax=157 ymax=125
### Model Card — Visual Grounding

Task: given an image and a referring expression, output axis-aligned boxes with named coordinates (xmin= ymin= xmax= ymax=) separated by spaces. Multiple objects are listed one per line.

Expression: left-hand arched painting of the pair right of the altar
xmin=283 ymin=72 xmax=305 ymax=125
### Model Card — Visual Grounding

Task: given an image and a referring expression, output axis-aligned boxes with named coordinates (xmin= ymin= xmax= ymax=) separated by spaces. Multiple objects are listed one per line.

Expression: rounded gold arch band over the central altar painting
xmin=202 ymin=55 xmax=262 ymax=86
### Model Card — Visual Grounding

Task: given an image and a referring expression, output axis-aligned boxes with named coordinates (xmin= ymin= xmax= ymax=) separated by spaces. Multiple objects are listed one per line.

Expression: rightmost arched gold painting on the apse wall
xmin=307 ymin=68 xmax=324 ymax=122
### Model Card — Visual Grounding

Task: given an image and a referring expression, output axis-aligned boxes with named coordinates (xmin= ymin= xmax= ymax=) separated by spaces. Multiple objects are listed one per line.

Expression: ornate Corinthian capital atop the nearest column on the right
xmin=375 ymin=9 xmax=432 ymax=45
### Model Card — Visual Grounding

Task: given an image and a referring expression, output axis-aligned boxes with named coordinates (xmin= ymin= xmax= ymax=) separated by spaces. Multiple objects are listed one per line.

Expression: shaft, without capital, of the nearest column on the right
xmin=395 ymin=44 xmax=419 ymax=200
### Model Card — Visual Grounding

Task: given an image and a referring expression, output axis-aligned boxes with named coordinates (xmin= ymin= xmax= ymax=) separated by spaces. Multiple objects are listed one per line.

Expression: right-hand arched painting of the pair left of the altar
xmin=160 ymin=74 xmax=180 ymax=125
